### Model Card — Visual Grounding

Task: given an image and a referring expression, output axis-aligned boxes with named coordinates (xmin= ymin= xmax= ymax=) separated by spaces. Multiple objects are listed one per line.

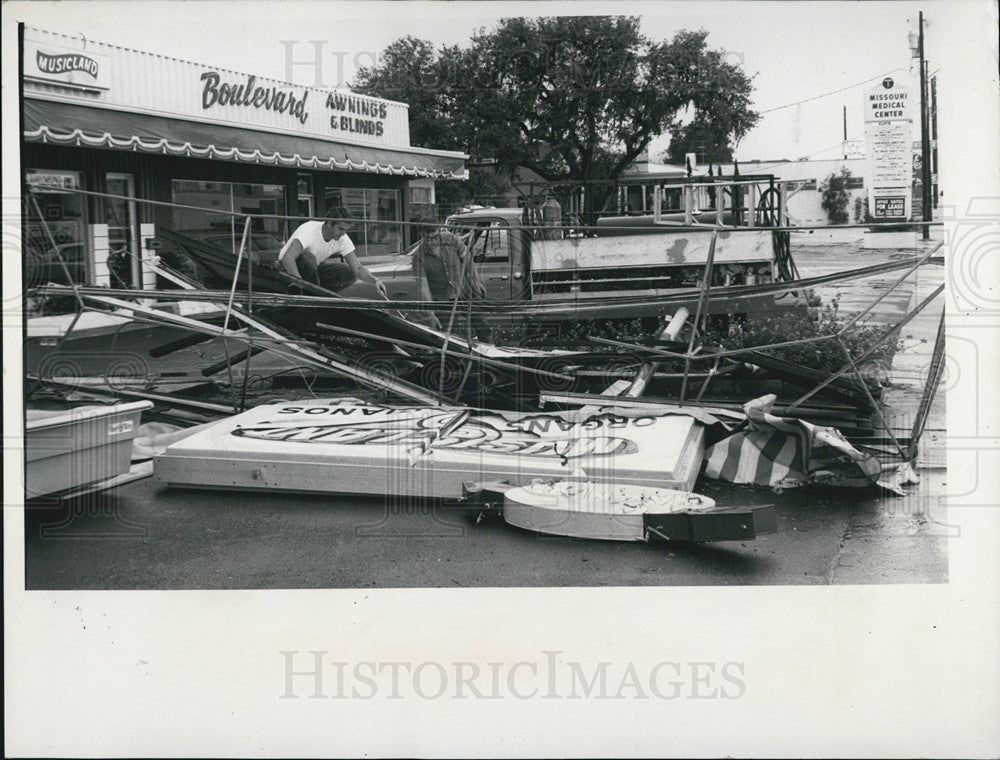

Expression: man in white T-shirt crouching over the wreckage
xmin=278 ymin=206 xmax=387 ymax=298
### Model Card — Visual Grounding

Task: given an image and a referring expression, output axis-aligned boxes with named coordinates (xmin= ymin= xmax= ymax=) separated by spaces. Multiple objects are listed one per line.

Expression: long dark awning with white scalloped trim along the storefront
xmin=24 ymin=98 xmax=468 ymax=179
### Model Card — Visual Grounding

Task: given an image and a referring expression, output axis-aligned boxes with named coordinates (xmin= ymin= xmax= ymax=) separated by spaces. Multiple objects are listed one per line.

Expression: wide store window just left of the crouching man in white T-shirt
xmin=171 ymin=179 xmax=287 ymax=251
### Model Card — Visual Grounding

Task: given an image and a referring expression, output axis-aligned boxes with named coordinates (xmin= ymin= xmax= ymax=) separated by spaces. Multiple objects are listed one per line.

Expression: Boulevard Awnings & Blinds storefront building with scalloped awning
xmin=21 ymin=27 xmax=468 ymax=286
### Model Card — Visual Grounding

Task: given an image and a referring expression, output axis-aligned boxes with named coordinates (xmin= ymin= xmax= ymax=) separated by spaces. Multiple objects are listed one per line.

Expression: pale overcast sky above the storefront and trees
xmin=5 ymin=0 xmax=996 ymax=161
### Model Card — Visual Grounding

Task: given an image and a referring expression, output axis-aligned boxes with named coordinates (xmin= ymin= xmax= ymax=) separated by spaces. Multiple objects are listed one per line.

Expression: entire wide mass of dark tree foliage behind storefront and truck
xmin=355 ymin=16 xmax=758 ymax=197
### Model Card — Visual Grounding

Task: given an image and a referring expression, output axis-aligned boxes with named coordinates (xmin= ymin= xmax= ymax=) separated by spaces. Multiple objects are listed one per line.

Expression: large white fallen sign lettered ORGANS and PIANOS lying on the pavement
xmin=154 ymin=399 xmax=705 ymax=500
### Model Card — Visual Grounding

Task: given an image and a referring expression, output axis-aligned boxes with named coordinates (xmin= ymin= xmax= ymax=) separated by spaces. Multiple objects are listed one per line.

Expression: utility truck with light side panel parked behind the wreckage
xmin=341 ymin=208 xmax=807 ymax=323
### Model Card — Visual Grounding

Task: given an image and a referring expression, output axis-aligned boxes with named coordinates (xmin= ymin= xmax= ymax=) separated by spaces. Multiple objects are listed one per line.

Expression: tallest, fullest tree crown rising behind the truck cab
xmin=448 ymin=16 xmax=756 ymax=186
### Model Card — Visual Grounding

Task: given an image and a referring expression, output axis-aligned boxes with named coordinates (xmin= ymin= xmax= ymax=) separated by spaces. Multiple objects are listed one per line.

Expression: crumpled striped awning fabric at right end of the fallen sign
xmin=705 ymin=394 xmax=882 ymax=488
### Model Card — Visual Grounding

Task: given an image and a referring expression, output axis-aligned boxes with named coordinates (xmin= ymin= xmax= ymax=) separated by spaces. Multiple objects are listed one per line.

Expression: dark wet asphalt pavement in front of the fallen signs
xmin=17 ymin=470 xmax=947 ymax=589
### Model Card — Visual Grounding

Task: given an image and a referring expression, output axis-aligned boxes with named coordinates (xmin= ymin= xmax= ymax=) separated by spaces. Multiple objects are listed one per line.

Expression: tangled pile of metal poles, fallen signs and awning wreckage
xmin=26 ymin=202 xmax=943 ymax=540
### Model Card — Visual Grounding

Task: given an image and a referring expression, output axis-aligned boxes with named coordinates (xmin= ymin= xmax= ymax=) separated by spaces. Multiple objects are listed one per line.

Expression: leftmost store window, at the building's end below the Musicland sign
xmin=24 ymin=169 xmax=93 ymax=287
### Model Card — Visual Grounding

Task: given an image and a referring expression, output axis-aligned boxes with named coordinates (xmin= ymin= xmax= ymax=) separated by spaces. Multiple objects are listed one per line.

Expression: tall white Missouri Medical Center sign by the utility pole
xmin=864 ymin=77 xmax=914 ymax=221
